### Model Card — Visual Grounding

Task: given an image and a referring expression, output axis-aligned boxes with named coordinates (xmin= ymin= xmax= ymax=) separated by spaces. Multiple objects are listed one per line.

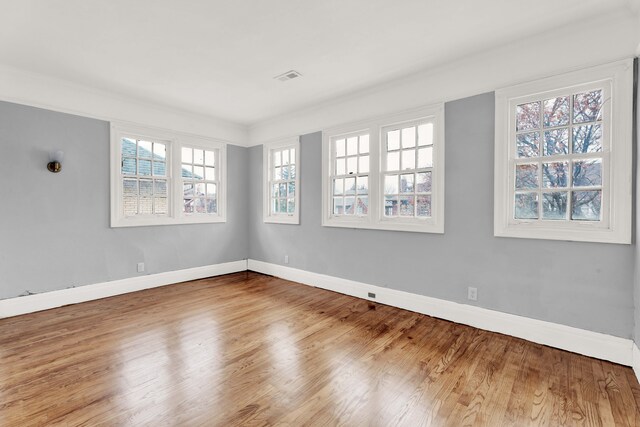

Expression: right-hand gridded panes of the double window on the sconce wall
xmin=180 ymin=146 xmax=218 ymax=215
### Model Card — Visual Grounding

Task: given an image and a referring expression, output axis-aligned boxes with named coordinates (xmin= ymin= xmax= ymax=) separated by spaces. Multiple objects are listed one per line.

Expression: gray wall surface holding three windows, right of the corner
xmin=249 ymin=93 xmax=635 ymax=338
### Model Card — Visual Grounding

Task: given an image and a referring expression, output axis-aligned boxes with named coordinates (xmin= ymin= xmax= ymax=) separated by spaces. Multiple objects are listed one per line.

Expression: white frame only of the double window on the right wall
xmin=322 ymin=103 xmax=445 ymax=233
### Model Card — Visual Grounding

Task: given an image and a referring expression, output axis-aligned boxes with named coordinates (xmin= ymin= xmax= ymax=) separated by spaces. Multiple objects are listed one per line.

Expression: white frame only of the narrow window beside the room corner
xmin=262 ymin=137 xmax=301 ymax=224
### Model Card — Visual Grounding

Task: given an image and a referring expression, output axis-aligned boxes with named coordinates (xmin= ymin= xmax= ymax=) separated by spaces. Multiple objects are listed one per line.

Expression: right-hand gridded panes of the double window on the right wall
xmin=382 ymin=122 xmax=433 ymax=218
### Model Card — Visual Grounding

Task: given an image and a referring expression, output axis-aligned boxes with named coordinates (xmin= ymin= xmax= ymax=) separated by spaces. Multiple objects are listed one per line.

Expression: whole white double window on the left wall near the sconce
xmin=111 ymin=125 xmax=226 ymax=227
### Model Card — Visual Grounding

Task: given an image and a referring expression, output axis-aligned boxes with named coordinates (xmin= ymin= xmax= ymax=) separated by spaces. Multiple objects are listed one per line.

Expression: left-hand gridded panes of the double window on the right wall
xmin=331 ymin=133 xmax=370 ymax=216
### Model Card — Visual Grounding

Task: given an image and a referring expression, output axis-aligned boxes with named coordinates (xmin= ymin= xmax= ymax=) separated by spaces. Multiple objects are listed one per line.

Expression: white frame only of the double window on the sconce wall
xmin=110 ymin=123 xmax=227 ymax=228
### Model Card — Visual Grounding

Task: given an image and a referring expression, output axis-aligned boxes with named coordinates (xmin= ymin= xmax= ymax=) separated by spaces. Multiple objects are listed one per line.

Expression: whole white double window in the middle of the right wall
xmin=323 ymin=105 xmax=444 ymax=233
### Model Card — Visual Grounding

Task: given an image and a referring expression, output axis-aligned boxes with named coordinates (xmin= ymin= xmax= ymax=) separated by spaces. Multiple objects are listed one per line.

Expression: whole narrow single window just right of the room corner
xmin=263 ymin=139 xmax=300 ymax=224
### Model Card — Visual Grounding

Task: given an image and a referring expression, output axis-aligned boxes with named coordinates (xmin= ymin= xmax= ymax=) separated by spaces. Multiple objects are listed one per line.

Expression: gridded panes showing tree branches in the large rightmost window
xmin=511 ymin=90 xmax=609 ymax=222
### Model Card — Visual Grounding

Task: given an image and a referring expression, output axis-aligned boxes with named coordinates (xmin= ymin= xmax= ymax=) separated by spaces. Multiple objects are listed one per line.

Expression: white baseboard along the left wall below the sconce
xmin=0 ymin=260 xmax=247 ymax=319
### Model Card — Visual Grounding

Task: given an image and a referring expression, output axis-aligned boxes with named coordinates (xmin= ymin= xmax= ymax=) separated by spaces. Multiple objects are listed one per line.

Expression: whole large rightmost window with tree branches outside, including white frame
xmin=495 ymin=61 xmax=633 ymax=243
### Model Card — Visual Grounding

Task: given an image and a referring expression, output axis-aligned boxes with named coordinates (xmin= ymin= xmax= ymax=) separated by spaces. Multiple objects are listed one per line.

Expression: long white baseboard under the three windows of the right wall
xmin=248 ymin=259 xmax=640 ymax=366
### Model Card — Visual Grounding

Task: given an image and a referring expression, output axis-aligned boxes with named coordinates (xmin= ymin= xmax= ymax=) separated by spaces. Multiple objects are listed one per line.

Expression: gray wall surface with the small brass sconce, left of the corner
xmin=0 ymin=102 xmax=249 ymax=299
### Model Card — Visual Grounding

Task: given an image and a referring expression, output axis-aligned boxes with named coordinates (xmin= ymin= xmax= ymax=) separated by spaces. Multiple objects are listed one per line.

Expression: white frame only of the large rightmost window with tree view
xmin=494 ymin=60 xmax=633 ymax=244
